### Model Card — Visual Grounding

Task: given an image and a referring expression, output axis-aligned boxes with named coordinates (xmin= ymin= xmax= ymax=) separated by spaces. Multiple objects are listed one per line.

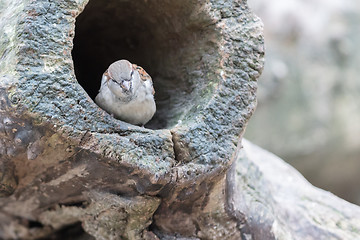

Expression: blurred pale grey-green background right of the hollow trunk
xmin=245 ymin=0 xmax=360 ymax=205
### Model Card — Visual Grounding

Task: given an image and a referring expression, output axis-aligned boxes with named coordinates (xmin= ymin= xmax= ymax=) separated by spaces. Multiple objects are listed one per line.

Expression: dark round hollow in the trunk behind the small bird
xmin=72 ymin=0 xmax=219 ymax=129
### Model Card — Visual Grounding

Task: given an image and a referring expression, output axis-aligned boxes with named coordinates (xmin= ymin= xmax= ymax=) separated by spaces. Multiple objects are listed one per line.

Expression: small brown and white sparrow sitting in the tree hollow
xmin=95 ymin=59 xmax=156 ymax=127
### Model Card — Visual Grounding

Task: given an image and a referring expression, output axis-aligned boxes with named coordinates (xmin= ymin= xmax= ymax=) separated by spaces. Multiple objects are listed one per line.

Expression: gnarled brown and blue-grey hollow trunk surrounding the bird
xmin=0 ymin=0 xmax=356 ymax=239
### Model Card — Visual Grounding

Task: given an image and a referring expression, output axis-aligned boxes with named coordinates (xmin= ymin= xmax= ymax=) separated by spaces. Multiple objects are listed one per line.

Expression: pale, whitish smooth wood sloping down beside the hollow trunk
xmin=232 ymin=140 xmax=360 ymax=240
